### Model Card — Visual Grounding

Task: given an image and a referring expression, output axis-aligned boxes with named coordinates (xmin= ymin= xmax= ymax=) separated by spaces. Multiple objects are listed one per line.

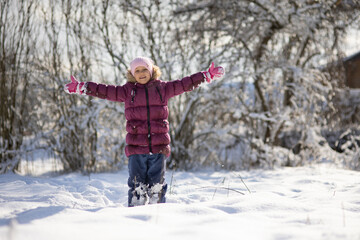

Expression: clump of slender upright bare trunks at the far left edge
xmin=0 ymin=1 xmax=38 ymax=173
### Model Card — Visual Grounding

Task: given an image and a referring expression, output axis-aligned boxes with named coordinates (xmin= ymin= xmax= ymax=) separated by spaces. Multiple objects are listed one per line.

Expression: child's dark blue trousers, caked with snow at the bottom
xmin=128 ymin=154 xmax=167 ymax=207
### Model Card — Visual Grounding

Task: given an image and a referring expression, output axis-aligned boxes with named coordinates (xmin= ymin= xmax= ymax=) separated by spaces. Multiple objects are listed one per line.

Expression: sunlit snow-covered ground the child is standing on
xmin=0 ymin=162 xmax=360 ymax=240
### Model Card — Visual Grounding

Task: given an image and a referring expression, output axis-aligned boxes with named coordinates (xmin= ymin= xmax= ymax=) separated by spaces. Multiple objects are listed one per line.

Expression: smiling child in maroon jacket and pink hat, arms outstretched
xmin=65 ymin=57 xmax=224 ymax=206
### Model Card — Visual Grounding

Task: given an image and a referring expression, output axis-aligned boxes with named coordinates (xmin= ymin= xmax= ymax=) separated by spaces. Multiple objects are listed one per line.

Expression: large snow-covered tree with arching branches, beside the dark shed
xmin=170 ymin=0 xmax=360 ymax=169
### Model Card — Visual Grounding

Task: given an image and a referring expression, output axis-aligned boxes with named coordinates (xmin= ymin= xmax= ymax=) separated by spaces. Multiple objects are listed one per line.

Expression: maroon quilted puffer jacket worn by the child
xmin=86 ymin=72 xmax=204 ymax=156
